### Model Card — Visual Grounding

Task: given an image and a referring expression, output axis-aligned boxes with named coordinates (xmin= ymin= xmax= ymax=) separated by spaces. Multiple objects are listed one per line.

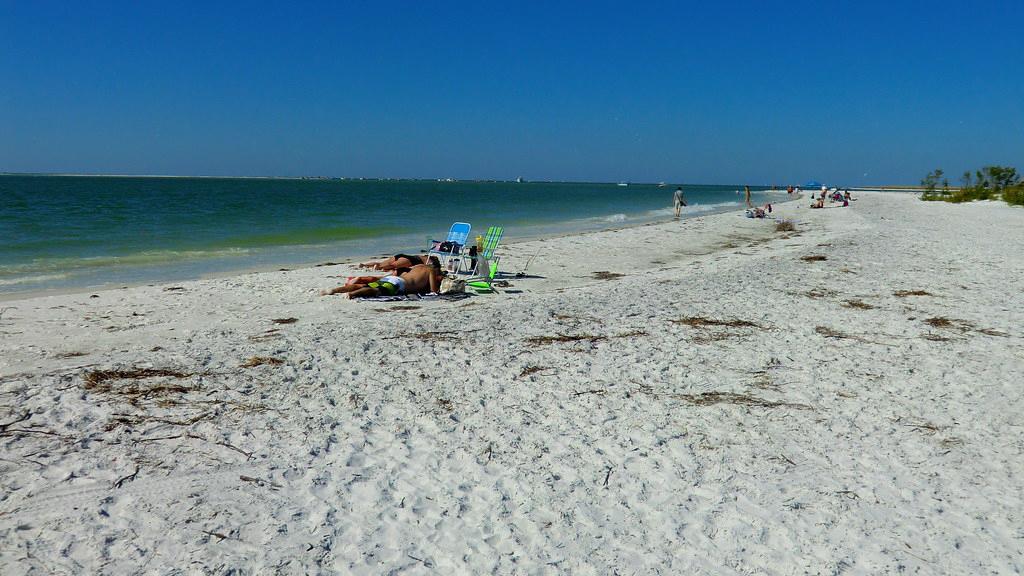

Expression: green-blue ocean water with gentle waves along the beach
xmin=0 ymin=175 xmax=785 ymax=294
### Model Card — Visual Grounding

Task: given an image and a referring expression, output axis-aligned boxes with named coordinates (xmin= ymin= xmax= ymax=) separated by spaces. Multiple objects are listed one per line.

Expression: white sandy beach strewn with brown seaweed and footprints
xmin=0 ymin=193 xmax=1024 ymax=575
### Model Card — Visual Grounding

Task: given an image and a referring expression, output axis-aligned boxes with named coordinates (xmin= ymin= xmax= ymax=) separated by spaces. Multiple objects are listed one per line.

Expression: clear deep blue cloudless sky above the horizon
xmin=0 ymin=0 xmax=1024 ymax=186
